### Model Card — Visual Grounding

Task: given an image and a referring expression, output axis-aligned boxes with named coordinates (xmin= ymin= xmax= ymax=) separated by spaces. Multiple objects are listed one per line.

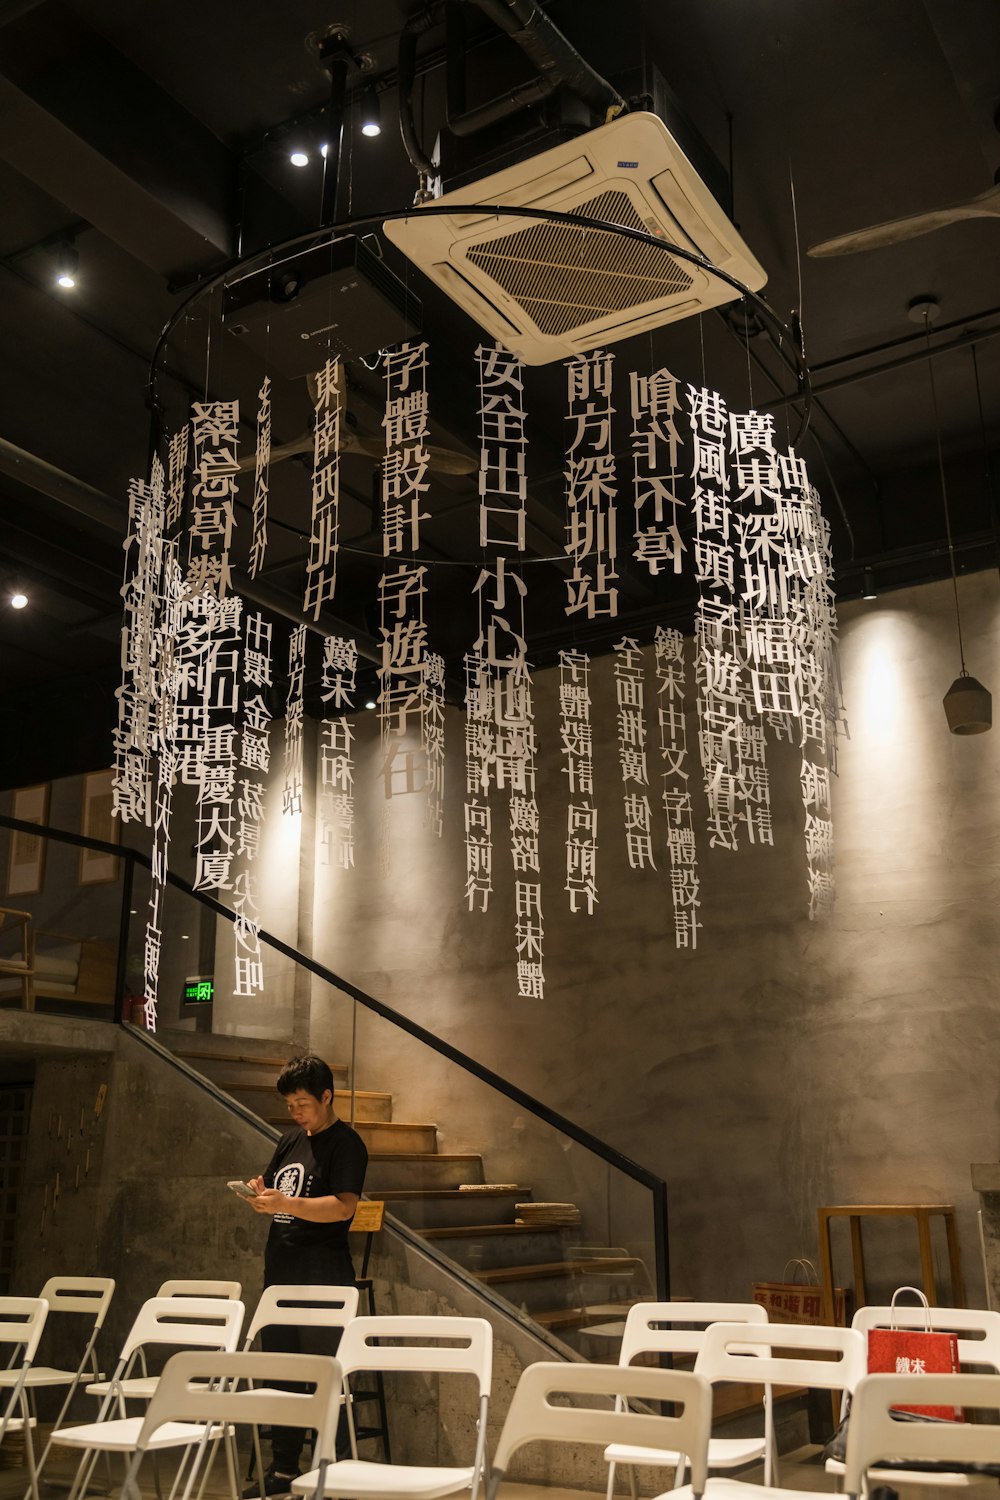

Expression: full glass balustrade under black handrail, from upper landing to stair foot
xmin=0 ymin=825 xmax=667 ymax=1359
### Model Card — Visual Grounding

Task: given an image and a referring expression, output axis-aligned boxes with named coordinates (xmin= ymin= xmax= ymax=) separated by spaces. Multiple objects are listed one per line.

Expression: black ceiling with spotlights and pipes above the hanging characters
xmin=0 ymin=0 xmax=1000 ymax=786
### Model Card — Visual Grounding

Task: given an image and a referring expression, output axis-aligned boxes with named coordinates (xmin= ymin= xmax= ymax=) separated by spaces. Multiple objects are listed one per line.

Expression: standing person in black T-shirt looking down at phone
xmin=244 ymin=1055 xmax=367 ymax=1500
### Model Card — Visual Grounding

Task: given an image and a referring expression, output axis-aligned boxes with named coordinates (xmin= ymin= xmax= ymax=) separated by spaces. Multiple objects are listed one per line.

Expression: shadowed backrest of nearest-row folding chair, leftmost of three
xmin=138 ymin=1350 xmax=342 ymax=1464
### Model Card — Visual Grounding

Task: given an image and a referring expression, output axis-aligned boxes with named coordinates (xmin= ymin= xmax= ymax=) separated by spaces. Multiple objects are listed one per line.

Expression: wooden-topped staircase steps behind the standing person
xmin=159 ymin=1032 xmax=654 ymax=1359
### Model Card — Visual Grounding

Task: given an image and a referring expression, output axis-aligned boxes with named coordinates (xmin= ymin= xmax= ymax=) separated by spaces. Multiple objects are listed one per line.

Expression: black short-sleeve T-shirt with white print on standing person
xmin=264 ymin=1121 xmax=367 ymax=1259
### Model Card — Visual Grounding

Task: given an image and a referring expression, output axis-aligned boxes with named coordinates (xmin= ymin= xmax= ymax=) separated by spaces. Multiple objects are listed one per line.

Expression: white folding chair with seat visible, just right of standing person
xmin=292 ymin=1316 xmax=493 ymax=1500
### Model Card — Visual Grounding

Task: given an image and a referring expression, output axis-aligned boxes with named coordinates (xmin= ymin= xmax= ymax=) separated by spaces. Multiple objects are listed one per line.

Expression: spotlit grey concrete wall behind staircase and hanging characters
xmin=312 ymin=575 xmax=1000 ymax=1301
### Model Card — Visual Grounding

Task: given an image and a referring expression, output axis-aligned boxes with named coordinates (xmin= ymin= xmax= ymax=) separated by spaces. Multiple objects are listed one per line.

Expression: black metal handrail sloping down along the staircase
xmin=0 ymin=813 xmax=670 ymax=1302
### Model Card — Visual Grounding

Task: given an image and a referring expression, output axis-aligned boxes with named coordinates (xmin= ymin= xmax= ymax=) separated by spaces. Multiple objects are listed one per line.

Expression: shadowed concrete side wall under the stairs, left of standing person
xmin=16 ymin=1019 xmax=270 ymax=1362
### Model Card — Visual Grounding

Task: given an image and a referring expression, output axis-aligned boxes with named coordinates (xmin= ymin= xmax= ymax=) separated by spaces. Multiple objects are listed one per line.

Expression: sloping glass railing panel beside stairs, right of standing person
xmin=310 ymin=981 xmax=657 ymax=1359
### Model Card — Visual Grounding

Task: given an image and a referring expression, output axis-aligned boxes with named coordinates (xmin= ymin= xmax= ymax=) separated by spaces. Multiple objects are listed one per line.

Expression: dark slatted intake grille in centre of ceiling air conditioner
xmin=466 ymin=189 xmax=691 ymax=336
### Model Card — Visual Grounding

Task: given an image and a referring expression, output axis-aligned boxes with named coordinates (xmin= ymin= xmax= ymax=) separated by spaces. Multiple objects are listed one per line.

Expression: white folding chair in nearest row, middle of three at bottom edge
xmin=487 ymin=1362 xmax=712 ymax=1500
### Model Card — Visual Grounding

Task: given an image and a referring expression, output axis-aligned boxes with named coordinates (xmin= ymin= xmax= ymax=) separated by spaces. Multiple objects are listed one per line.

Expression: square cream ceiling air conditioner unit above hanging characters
xmin=385 ymin=114 xmax=768 ymax=365
